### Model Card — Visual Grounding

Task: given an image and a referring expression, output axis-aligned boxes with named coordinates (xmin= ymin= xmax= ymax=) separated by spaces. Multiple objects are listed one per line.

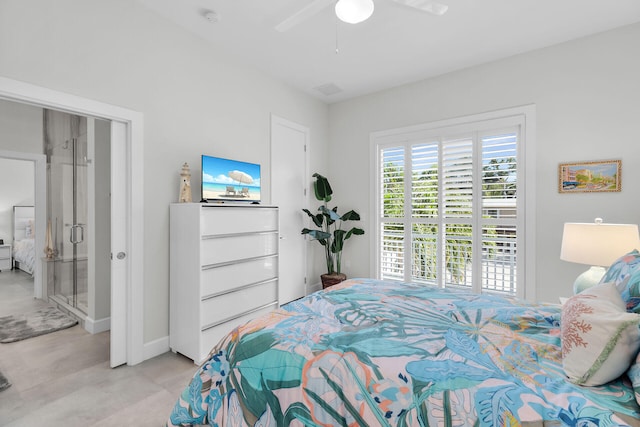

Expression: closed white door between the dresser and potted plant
xmin=271 ymin=116 xmax=309 ymax=305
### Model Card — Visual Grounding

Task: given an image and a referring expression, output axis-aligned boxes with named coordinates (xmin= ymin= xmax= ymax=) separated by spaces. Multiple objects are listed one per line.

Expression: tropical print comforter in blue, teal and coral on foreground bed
xmin=168 ymin=279 xmax=640 ymax=427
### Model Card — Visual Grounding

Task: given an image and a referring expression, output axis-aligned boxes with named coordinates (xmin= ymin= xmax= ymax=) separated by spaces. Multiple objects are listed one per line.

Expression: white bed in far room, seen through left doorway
xmin=13 ymin=206 xmax=36 ymax=274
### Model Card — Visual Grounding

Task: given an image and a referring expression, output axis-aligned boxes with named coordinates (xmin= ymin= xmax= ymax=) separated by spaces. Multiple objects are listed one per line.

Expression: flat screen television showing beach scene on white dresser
xmin=201 ymin=154 xmax=260 ymax=203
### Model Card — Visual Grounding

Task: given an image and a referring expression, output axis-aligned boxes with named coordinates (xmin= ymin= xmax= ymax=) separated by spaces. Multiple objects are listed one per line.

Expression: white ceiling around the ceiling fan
xmin=138 ymin=0 xmax=640 ymax=103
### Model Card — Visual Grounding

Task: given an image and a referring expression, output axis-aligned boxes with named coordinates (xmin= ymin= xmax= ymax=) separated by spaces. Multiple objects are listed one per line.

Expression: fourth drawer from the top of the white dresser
xmin=200 ymin=280 xmax=278 ymax=329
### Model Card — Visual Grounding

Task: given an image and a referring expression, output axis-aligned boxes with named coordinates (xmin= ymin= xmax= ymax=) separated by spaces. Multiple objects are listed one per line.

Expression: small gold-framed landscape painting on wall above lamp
xmin=558 ymin=160 xmax=622 ymax=193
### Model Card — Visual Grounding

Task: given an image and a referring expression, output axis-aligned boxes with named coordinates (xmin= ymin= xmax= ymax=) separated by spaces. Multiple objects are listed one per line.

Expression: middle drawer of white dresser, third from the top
xmin=200 ymin=255 xmax=278 ymax=297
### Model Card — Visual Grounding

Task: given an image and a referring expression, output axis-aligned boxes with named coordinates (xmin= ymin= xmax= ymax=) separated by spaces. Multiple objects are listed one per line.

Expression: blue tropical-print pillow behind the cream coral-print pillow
xmin=600 ymin=249 xmax=640 ymax=313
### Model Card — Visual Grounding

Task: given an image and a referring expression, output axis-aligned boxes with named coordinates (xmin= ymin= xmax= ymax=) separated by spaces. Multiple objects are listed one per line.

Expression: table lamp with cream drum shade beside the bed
xmin=560 ymin=218 xmax=640 ymax=294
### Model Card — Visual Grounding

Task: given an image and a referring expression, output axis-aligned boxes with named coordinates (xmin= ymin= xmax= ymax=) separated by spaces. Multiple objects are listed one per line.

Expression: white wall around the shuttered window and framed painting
xmin=327 ymin=24 xmax=640 ymax=302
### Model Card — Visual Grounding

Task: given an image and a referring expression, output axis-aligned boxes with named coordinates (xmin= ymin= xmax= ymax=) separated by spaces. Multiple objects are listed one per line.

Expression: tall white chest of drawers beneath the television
xmin=169 ymin=203 xmax=278 ymax=363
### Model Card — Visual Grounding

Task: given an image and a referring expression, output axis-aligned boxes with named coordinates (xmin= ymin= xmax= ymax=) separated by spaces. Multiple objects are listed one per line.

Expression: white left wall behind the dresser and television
xmin=0 ymin=0 xmax=328 ymax=343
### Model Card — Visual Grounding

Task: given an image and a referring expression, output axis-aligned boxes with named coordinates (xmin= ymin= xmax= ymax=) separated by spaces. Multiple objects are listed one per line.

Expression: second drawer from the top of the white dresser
xmin=200 ymin=232 xmax=278 ymax=266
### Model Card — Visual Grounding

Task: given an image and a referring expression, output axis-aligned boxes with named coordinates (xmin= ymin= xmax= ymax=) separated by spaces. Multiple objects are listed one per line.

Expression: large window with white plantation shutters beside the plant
xmin=372 ymin=110 xmax=527 ymax=297
